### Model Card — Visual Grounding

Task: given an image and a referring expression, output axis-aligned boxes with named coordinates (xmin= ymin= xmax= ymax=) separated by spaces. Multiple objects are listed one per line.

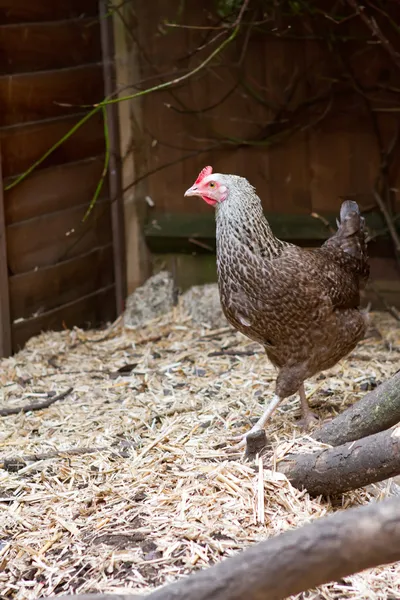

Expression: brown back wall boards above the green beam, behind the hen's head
xmin=136 ymin=1 xmax=400 ymax=223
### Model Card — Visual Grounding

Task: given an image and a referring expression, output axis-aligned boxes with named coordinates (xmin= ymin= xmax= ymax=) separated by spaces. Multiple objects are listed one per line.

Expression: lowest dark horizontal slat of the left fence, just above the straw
xmin=12 ymin=285 xmax=115 ymax=352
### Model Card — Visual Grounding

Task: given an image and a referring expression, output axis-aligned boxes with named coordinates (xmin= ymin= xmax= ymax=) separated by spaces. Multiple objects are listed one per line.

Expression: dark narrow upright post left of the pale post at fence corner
xmin=99 ymin=0 xmax=126 ymax=314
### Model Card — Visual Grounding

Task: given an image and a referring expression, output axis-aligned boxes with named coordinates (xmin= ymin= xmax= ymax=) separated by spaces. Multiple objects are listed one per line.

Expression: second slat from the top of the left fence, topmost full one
xmin=0 ymin=18 xmax=101 ymax=75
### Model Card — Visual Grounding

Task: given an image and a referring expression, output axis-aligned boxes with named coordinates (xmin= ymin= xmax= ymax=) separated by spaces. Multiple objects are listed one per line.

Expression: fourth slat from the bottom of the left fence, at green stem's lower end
xmin=4 ymin=156 xmax=109 ymax=225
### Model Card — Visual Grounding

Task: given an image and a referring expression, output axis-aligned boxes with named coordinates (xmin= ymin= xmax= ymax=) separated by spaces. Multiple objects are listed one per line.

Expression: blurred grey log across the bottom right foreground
xmin=44 ymin=498 xmax=400 ymax=600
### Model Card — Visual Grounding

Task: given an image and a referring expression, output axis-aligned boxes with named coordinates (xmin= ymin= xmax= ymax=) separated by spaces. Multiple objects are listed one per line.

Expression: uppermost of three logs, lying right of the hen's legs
xmin=312 ymin=371 xmax=400 ymax=446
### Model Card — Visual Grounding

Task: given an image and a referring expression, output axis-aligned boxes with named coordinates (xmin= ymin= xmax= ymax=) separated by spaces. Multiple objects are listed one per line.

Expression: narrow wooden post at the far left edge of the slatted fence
xmin=0 ymin=152 xmax=11 ymax=357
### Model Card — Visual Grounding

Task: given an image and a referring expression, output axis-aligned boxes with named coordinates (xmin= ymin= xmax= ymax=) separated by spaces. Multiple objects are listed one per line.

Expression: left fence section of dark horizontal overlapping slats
xmin=0 ymin=0 xmax=125 ymax=355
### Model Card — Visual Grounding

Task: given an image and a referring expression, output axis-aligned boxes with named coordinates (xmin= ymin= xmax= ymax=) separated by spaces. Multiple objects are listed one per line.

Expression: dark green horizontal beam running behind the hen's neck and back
xmin=144 ymin=212 xmax=400 ymax=253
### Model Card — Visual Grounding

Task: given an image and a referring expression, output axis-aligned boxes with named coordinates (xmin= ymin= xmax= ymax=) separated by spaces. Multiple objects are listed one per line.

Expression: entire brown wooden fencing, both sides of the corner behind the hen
xmin=0 ymin=0 xmax=400 ymax=355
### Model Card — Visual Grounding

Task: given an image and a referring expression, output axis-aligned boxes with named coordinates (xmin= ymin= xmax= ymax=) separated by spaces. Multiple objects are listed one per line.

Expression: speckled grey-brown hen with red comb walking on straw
xmin=185 ymin=167 xmax=369 ymax=446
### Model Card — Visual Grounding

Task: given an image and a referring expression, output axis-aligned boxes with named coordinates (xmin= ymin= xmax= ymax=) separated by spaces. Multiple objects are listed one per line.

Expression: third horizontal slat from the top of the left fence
xmin=0 ymin=64 xmax=104 ymax=127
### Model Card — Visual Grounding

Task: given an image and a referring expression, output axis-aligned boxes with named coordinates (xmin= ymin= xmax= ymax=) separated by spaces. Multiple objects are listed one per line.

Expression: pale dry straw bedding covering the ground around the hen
xmin=0 ymin=309 xmax=400 ymax=600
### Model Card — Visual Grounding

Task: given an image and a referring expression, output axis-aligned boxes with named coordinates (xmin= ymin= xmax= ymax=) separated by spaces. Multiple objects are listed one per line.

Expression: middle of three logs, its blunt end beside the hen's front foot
xmin=276 ymin=427 xmax=400 ymax=496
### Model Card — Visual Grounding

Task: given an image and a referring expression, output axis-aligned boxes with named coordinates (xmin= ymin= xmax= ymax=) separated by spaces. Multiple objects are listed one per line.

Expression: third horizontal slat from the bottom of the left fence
xmin=7 ymin=201 xmax=111 ymax=275
